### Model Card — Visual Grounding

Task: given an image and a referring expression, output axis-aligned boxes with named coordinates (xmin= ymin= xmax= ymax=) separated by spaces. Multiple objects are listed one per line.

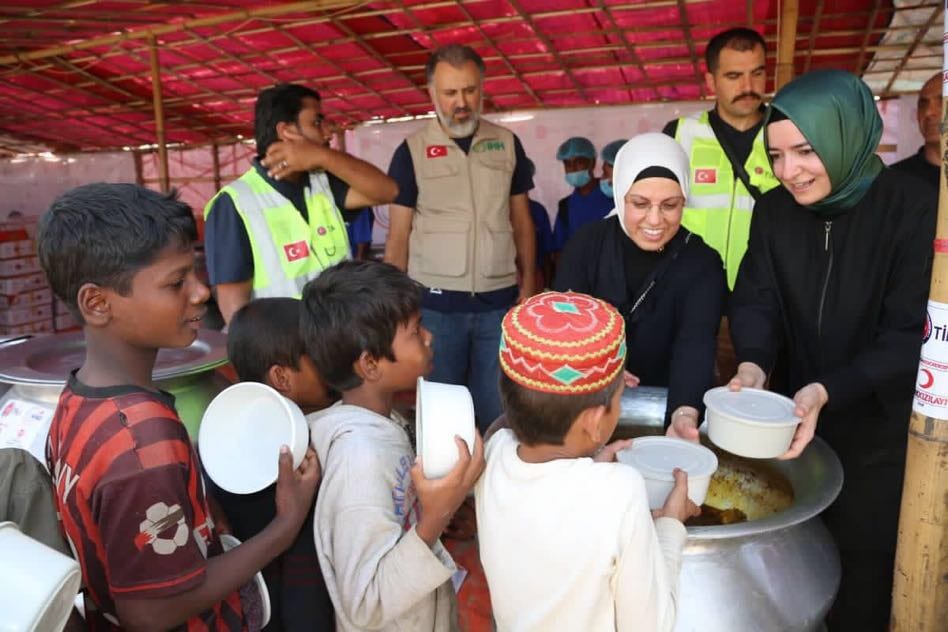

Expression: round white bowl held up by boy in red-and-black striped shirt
xmin=198 ymin=382 xmax=309 ymax=494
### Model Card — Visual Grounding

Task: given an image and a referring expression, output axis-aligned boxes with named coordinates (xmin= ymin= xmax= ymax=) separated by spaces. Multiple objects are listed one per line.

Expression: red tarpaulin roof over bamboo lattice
xmin=0 ymin=0 xmax=941 ymax=151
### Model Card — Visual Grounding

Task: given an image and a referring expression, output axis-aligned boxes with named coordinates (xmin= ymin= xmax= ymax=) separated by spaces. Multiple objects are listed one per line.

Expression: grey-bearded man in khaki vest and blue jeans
xmin=385 ymin=44 xmax=536 ymax=431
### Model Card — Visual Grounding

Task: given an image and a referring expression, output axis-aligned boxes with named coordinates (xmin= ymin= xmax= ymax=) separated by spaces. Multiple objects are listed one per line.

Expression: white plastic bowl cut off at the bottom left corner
xmin=0 ymin=522 xmax=82 ymax=631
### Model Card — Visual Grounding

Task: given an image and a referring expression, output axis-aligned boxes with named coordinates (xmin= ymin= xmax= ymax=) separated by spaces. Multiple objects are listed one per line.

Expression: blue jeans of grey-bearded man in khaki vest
xmin=421 ymin=309 xmax=507 ymax=434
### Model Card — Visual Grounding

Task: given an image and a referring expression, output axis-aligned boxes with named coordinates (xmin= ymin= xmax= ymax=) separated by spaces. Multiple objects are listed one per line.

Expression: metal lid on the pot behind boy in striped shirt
xmin=0 ymin=329 xmax=227 ymax=385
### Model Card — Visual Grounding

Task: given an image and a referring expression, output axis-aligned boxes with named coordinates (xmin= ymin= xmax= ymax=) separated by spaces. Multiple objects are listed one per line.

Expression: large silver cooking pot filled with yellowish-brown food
xmin=616 ymin=387 xmax=843 ymax=632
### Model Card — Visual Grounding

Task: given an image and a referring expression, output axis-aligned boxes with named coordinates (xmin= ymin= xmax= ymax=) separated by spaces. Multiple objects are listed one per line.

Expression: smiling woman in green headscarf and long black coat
xmin=730 ymin=71 xmax=936 ymax=630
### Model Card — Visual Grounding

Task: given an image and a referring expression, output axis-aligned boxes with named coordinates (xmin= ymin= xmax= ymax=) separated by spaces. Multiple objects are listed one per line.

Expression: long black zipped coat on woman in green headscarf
xmin=730 ymin=169 xmax=936 ymax=556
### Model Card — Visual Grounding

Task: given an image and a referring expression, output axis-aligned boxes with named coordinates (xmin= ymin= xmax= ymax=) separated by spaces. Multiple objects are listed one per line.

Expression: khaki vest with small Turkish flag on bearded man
xmin=406 ymin=119 xmax=517 ymax=293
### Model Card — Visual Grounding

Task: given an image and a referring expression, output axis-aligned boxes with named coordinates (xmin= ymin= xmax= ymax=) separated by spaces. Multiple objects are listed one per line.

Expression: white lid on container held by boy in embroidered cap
xmin=616 ymin=437 xmax=718 ymax=481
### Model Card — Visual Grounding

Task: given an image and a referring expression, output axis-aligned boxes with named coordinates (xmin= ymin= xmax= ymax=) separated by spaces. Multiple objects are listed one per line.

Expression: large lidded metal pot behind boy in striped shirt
xmin=0 ymin=329 xmax=229 ymax=462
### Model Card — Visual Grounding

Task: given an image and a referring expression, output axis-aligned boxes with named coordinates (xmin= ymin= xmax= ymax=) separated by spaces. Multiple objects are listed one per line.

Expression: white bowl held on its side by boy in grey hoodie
xmin=415 ymin=377 xmax=475 ymax=478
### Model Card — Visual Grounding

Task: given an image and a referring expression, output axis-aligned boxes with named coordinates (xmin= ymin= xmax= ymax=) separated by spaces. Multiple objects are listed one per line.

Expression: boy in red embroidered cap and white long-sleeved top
xmin=475 ymin=292 xmax=697 ymax=632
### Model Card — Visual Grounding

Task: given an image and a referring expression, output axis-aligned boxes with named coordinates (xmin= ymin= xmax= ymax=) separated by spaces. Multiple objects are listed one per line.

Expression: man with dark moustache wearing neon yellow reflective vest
xmin=662 ymin=28 xmax=780 ymax=289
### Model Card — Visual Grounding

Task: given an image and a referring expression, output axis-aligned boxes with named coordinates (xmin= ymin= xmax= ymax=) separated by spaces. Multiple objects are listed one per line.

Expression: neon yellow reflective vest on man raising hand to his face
xmin=204 ymin=167 xmax=350 ymax=298
